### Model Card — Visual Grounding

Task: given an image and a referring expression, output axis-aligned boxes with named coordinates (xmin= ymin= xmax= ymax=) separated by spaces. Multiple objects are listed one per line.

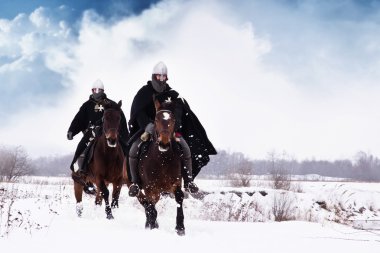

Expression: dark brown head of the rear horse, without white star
xmin=103 ymin=100 xmax=121 ymax=148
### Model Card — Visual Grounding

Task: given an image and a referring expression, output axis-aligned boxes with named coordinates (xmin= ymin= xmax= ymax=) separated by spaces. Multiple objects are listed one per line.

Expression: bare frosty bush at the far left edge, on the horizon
xmin=0 ymin=146 xmax=33 ymax=182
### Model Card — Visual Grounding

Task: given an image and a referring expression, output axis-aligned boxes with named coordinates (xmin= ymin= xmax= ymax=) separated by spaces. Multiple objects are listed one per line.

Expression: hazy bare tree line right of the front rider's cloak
xmin=201 ymin=150 xmax=380 ymax=182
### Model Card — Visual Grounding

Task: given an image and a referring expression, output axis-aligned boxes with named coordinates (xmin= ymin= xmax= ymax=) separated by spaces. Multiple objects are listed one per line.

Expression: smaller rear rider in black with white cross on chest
xmin=67 ymin=79 xmax=128 ymax=193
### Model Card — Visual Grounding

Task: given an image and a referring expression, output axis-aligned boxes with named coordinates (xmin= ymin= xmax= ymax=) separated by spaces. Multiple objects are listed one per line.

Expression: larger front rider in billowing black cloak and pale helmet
xmin=129 ymin=62 xmax=216 ymax=197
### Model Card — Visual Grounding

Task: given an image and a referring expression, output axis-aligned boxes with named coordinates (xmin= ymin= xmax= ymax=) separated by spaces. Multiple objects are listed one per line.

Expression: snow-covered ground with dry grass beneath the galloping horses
xmin=0 ymin=178 xmax=380 ymax=253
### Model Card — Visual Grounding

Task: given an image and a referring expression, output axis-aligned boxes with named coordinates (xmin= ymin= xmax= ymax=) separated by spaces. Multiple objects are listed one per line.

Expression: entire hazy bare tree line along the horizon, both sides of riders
xmin=0 ymin=146 xmax=380 ymax=182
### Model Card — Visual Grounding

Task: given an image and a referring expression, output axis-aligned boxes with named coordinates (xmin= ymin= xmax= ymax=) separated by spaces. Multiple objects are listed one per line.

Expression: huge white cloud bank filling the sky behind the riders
xmin=0 ymin=1 xmax=380 ymax=159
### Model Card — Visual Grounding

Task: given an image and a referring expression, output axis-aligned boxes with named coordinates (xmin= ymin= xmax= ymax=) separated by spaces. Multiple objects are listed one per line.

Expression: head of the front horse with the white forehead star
xmin=154 ymin=99 xmax=175 ymax=152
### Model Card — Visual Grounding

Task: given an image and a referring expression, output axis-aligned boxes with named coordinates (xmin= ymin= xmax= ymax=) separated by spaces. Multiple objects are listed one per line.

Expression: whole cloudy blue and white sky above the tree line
xmin=0 ymin=0 xmax=380 ymax=160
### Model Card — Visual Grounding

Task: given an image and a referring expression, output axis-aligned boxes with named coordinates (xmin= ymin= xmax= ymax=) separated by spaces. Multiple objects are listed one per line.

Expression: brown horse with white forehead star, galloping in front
xmin=133 ymin=100 xmax=185 ymax=235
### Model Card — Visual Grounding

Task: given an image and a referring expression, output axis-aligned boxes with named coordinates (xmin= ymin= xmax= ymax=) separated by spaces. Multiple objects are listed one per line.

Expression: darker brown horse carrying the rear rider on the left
xmin=74 ymin=101 xmax=124 ymax=219
